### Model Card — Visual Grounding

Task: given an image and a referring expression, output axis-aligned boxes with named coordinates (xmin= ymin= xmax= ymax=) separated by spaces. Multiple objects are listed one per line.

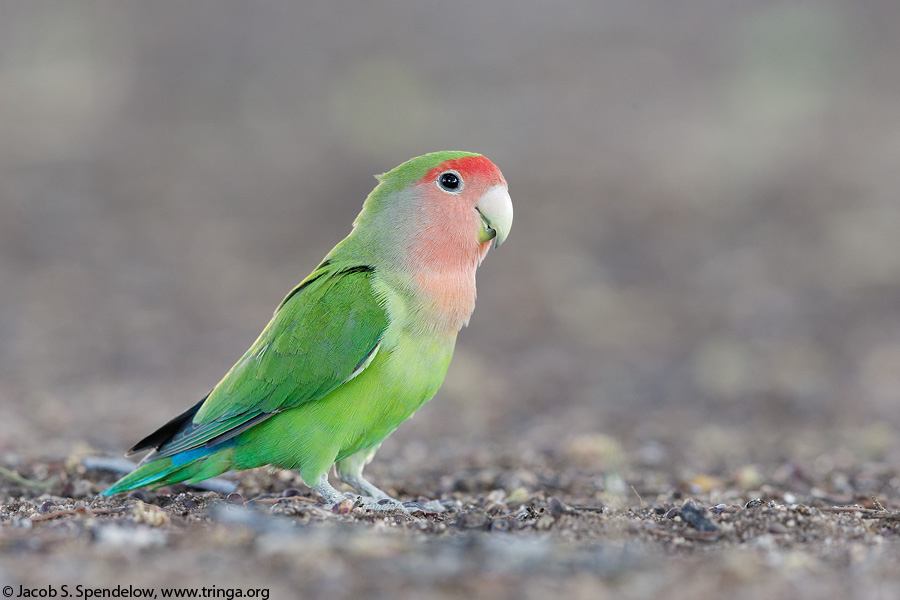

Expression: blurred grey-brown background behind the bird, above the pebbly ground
xmin=0 ymin=0 xmax=900 ymax=474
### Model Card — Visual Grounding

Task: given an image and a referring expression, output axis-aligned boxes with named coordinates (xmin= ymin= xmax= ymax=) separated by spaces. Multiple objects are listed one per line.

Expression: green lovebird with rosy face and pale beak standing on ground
xmin=103 ymin=152 xmax=513 ymax=508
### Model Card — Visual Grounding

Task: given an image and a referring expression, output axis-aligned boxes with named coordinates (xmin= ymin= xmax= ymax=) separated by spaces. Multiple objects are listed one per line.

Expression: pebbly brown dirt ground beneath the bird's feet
xmin=0 ymin=432 xmax=900 ymax=598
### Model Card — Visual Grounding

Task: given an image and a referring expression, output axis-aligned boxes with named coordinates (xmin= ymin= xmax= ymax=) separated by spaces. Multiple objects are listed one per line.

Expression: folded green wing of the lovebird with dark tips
xmin=143 ymin=261 xmax=388 ymax=460
